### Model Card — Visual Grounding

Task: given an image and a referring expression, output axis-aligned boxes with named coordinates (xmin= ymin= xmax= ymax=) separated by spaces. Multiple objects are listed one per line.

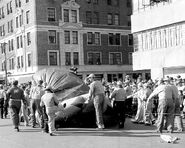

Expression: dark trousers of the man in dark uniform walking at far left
xmin=10 ymin=101 xmax=21 ymax=128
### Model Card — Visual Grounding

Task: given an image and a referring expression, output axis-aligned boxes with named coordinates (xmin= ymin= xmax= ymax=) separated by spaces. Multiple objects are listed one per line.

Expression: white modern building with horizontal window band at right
xmin=131 ymin=0 xmax=185 ymax=79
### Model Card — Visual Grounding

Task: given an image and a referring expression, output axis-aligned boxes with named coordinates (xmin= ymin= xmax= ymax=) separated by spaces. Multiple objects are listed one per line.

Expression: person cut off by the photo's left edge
xmin=0 ymin=85 xmax=6 ymax=119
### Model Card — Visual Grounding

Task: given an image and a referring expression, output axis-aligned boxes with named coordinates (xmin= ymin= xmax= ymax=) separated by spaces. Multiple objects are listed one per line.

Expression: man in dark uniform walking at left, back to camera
xmin=7 ymin=80 xmax=26 ymax=132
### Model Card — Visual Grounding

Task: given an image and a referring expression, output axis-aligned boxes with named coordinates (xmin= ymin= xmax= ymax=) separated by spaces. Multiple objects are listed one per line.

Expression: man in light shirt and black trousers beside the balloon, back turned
xmin=110 ymin=81 xmax=127 ymax=128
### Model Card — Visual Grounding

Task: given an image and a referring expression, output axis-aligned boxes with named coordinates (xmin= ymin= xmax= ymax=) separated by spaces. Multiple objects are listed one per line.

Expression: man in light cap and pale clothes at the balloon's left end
xmin=40 ymin=86 xmax=59 ymax=136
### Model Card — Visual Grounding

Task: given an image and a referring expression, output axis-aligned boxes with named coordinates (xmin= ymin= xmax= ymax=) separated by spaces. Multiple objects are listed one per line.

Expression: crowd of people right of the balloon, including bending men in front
xmin=102 ymin=76 xmax=185 ymax=133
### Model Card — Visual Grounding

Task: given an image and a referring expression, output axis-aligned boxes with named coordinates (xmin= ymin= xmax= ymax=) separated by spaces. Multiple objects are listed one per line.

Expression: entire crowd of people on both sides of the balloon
xmin=0 ymin=74 xmax=185 ymax=136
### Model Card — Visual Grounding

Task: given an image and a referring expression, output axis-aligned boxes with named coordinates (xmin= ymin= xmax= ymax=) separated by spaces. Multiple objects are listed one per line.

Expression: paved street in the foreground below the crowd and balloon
xmin=0 ymin=119 xmax=185 ymax=148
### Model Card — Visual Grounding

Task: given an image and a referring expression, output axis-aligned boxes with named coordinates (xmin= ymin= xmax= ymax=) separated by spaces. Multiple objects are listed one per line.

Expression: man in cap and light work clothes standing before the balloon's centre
xmin=87 ymin=74 xmax=105 ymax=129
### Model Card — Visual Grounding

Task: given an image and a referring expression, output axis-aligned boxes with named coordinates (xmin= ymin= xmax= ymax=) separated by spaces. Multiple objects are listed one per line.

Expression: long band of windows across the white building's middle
xmin=134 ymin=25 xmax=185 ymax=51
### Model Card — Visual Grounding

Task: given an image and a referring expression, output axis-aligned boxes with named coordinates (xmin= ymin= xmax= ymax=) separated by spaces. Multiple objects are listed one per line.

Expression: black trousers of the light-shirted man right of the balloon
xmin=113 ymin=101 xmax=125 ymax=128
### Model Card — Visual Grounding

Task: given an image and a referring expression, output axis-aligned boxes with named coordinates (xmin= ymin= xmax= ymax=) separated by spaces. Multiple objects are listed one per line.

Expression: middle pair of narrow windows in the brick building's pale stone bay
xmin=64 ymin=30 xmax=78 ymax=44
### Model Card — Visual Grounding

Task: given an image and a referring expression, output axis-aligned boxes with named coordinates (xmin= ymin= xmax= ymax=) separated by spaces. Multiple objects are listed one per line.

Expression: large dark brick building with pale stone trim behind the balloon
xmin=0 ymin=0 xmax=133 ymax=82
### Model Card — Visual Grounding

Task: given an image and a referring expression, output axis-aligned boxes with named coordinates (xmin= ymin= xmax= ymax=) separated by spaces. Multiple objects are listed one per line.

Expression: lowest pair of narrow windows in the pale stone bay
xmin=65 ymin=52 xmax=79 ymax=66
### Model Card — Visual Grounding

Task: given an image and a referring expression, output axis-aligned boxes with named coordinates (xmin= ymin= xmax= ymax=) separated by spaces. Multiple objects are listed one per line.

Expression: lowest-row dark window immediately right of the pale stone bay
xmin=87 ymin=52 xmax=101 ymax=65
